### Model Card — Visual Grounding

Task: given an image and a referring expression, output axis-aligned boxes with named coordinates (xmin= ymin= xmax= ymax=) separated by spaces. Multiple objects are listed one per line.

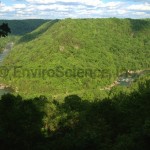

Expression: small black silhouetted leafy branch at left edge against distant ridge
xmin=0 ymin=23 xmax=11 ymax=37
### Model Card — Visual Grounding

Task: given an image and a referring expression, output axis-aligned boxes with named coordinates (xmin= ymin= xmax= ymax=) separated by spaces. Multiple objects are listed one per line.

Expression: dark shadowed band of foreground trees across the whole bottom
xmin=0 ymin=81 xmax=150 ymax=150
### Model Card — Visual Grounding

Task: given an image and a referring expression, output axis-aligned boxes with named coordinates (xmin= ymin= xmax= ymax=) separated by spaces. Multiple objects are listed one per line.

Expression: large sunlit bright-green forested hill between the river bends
xmin=1 ymin=18 xmax=150 ymax=98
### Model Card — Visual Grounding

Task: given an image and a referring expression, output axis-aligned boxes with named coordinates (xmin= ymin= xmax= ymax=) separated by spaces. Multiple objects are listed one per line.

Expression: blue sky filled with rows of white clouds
xmin=0 ymin=0 xmax=150 ymax=19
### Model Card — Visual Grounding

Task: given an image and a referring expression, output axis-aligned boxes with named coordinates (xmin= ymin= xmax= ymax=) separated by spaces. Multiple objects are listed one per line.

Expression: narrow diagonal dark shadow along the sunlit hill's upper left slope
xmin=18 ymin=19 xmax=59 ymax=44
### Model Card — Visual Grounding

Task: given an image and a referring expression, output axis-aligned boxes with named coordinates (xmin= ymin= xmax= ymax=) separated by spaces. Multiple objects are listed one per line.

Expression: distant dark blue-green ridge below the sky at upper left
xmin=0 ymin=19 xmax=48 ymax=35
